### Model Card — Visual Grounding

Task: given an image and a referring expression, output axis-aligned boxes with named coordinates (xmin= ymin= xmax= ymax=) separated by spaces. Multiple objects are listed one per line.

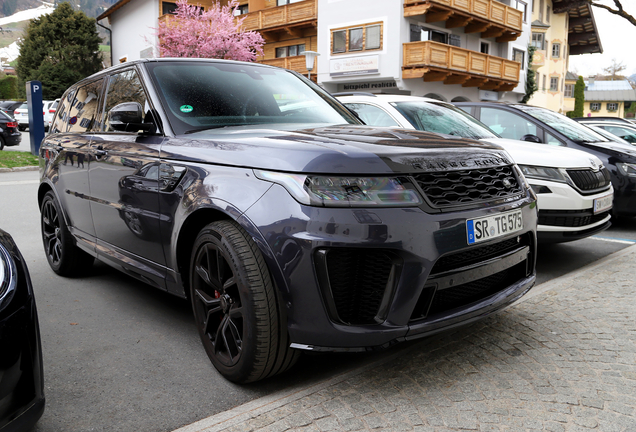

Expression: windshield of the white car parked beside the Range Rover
xmin=391 ymin=101 xmax=499 ymax=139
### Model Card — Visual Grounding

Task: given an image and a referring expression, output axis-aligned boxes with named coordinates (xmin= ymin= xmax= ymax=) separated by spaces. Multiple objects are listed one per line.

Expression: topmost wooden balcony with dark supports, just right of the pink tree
xmin=241 ymin=0 xmax=318 ymax=42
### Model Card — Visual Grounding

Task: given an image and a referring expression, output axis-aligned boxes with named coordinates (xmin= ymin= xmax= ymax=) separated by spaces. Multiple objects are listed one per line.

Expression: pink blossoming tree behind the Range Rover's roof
xmin=156 ymin=0 xmax=265 ymax=61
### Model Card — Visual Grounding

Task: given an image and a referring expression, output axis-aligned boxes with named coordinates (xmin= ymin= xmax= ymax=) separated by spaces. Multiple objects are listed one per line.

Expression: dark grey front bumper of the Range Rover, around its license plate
xmin=242 ymin=185 xmax=537 ymax=351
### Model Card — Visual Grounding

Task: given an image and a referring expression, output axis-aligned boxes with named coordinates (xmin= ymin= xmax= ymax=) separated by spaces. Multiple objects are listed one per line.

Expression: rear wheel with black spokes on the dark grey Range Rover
xmin=40 ymin=191 xmax=94 ymax=276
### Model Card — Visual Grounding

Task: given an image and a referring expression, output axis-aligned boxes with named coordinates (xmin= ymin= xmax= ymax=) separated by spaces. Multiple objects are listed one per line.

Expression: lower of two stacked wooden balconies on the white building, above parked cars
xmin=402 ymin=41 xmax=521 ymax=91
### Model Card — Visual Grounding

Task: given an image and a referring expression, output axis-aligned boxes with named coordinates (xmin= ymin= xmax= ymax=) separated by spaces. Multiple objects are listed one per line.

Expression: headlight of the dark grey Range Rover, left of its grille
xmin=254 ymin=170 xmax=422 ymax=207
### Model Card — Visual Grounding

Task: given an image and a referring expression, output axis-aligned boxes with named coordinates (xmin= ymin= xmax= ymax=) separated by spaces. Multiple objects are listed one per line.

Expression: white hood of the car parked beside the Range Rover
xmin=482 ymin=138 xmax=602 ymax=168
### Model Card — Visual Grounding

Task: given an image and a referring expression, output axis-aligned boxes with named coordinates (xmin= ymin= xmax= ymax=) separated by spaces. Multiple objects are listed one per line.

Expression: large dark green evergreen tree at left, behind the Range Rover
xmin=16 ymin=2 xmax=102 ymax=100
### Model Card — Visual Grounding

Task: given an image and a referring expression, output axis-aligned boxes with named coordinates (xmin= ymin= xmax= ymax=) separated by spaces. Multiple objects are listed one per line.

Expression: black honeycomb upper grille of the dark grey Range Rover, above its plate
xmin=413 ymin=166 xmax=522 ymax=208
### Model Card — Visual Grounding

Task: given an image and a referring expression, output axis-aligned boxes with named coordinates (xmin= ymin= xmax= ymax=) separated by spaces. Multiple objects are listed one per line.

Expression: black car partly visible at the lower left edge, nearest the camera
xmin=0 ymin=230 xmax=45 ymax=432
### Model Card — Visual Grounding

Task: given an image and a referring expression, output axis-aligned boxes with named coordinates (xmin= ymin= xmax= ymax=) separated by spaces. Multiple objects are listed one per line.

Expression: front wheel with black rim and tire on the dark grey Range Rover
xmin=190 ymin=221 xmax=299 ymax=383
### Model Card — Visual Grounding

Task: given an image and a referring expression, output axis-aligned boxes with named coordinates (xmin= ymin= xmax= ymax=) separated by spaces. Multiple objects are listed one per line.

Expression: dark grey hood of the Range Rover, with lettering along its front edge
xmin=161 ymin=125 xmax=513 ymax=174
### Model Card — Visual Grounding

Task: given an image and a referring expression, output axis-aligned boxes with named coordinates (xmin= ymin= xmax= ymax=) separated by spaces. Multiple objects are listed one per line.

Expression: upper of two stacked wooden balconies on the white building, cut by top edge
xmin=404 ymin=0 xmax=523 ymax=42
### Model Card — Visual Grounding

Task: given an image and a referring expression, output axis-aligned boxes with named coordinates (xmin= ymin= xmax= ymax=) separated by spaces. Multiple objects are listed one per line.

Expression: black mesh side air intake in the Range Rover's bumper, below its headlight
xmin=323 ymin=248 xmax=395 ymax=324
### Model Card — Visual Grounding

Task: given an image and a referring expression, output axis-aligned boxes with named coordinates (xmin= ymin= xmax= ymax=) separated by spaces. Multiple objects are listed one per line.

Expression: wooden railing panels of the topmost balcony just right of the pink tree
xmin=242 ymin=0 xmax=318 ymax=37
